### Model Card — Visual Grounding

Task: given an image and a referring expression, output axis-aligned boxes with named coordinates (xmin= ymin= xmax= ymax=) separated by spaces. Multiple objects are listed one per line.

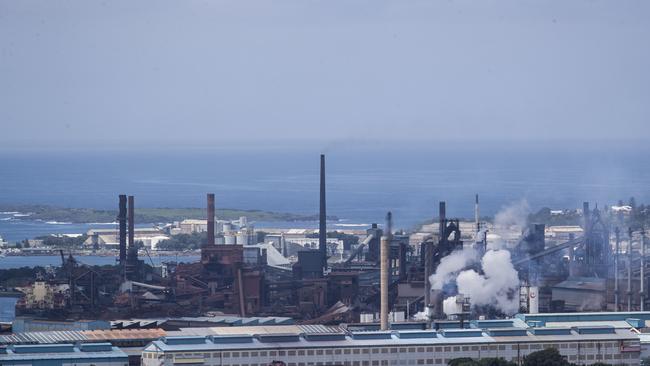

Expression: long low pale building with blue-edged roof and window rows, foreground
xmin=142 ymin=327 xmax=640 ymax=366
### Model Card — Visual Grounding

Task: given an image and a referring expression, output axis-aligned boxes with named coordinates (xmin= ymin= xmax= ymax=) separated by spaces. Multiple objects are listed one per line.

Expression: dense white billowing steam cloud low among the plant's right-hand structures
xmin=445 ymin=250 xmax=519 ymax=315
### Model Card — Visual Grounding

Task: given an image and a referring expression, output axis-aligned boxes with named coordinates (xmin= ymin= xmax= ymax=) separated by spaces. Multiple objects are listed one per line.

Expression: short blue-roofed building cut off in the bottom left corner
xmin=0 ymin=343 xmax=129 ymax=366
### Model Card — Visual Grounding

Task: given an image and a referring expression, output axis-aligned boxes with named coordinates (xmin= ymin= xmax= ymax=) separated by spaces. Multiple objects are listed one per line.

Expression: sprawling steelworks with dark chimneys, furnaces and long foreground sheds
xmin=0 ymin=155 xmax=650 ymax=366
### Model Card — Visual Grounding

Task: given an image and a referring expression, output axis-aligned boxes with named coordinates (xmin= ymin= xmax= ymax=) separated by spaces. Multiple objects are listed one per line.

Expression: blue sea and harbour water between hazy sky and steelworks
xmin=0 ymin=142 xmax=650 ymax=240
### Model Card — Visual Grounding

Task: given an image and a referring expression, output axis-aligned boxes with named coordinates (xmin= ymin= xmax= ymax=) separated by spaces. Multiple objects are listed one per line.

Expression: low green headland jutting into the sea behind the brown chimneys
xmin=0 ymin=205 xmax=337 ymax=223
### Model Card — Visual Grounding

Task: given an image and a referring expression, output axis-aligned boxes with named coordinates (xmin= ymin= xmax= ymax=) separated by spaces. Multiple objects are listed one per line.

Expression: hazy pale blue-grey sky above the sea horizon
xmin=0 ymin=0 xmax=650 ymax=145
